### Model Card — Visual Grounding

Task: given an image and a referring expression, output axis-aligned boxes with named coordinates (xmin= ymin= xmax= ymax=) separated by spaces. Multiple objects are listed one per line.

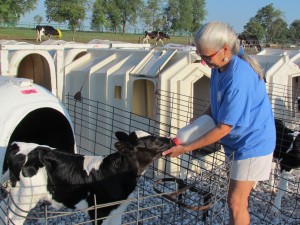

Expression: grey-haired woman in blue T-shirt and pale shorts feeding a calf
xmin=163 ymin=22 xmax=275 ymax=225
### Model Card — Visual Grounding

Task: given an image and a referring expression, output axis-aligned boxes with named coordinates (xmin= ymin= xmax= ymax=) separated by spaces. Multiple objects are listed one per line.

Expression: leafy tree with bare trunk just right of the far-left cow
xmin=45 ymin=0 xmax=88 ymax=41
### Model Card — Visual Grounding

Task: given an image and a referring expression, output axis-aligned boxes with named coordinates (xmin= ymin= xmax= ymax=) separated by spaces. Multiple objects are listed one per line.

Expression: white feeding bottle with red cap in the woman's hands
xmin=173 ymin=115 xmax=216 ymax=145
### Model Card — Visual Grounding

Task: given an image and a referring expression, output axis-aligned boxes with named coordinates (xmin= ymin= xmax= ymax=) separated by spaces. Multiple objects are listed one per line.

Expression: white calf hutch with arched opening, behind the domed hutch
xmin=0 ymin=41 xmax=64 ymax=95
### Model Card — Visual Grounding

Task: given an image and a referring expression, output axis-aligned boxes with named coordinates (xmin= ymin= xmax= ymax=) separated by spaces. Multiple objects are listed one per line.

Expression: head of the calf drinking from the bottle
xmin=115 ymin=131 xmax=174 ymax=175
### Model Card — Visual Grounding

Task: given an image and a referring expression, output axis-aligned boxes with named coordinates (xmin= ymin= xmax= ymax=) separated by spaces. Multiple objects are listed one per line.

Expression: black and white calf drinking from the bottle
xmin=0 ymin=131 xmax=174 ymax=225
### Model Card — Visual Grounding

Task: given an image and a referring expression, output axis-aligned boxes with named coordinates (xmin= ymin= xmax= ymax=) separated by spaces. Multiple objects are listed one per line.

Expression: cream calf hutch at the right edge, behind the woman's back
xmin=254 ymin=48 xmax=300 ymax=126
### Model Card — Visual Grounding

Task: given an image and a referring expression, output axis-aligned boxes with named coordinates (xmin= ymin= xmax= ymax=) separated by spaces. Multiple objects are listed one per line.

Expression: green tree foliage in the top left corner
xmin=0 ymin=0 xmax=37 ymax=23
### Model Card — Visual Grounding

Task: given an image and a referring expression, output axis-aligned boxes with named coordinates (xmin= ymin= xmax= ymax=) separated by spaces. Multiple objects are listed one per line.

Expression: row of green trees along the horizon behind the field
xmin=0 ymin=0 xmax=300 ymax=43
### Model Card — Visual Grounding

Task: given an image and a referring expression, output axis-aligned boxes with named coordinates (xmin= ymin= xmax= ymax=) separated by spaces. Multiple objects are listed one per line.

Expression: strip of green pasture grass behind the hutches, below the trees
xmin=0 ymin=27 xmax=191 ymax=44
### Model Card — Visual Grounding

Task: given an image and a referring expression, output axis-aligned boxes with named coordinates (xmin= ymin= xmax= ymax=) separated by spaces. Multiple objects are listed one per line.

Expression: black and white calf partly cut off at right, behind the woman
xmin=271 ymin=119 xmax=300 ymax=212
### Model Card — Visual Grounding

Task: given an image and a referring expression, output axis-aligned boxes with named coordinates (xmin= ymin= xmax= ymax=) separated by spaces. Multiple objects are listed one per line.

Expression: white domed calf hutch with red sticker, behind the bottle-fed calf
xmin=0 ymin=76 xmax=75 ymax=181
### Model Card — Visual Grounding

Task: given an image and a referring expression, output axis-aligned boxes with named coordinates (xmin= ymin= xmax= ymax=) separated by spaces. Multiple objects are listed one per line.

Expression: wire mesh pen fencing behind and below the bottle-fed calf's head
xmin=66 ymin=94 xmax=229 ymax=224
